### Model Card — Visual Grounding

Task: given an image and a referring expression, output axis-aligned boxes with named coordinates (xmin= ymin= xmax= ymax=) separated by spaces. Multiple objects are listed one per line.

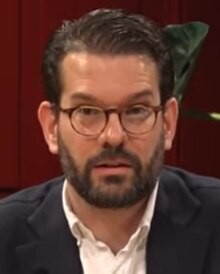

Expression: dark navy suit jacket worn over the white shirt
xmin=0 ymin=168 xmax=220 ymax=274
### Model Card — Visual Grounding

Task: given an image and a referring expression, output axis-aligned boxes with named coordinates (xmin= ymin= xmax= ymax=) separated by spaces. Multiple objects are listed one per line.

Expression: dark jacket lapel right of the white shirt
xmin=147 ymin=169 xmax=209 ymax=274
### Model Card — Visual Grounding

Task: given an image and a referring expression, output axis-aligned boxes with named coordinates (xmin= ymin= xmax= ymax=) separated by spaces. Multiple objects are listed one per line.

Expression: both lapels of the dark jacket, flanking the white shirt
xmin=17 ymin=169 xmax=209 ymax=274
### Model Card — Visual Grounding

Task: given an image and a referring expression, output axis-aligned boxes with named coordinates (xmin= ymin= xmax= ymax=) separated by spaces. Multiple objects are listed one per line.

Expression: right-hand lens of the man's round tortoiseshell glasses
xmin=121 ymin=105 xmax=156 ymax=134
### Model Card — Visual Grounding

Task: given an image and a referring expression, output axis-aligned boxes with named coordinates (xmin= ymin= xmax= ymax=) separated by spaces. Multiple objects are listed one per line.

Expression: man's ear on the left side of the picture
xmin=38 ymin=101 xmax=58 ymax=154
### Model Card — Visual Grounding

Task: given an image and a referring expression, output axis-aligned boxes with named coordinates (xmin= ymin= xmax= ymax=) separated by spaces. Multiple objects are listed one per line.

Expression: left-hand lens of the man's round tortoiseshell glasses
xmin=71 ymin=106 xmax=106 ymax=135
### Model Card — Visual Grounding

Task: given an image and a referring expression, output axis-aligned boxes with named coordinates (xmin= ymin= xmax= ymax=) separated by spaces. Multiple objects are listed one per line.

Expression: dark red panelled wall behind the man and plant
xmin=0 ymin=0 xmax=220 ymax=192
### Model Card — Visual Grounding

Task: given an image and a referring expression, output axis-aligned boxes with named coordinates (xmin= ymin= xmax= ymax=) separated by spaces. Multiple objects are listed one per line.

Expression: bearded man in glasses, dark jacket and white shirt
xmin=0 ymin=9 xmax=220 ymax=274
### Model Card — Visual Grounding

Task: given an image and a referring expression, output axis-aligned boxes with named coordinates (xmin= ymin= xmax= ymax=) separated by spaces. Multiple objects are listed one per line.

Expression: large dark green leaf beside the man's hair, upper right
xmin=164 ymin=22 xmax=209 ymax=102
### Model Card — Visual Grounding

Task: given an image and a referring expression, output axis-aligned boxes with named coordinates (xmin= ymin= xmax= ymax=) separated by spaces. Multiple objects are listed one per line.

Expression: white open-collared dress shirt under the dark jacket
xmin=62 ymin=180 xmax=158 ymax=274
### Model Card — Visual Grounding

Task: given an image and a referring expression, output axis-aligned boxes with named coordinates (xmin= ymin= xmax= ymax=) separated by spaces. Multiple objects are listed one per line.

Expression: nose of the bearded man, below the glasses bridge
xmin=99 ymin=113 xmax=127 ymax=147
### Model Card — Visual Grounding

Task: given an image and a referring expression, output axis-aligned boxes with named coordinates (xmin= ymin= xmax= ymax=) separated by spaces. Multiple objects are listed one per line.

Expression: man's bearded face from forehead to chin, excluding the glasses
xmin=42 ymin=53 xmax=177 ymax=208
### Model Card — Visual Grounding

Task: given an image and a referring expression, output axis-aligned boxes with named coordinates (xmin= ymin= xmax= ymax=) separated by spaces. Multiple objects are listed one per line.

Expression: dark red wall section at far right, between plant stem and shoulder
xmin=180 ymin=119 xmax=220 ymax=178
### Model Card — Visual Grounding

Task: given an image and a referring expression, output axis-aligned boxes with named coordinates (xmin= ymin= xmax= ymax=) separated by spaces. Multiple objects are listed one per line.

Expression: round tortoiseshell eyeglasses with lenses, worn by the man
xmin=52 ymin=104 xmax=163 ymax=136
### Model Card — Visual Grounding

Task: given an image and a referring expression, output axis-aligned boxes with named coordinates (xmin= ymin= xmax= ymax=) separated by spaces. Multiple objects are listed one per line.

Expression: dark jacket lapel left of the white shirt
xmin=17 ymin=184 xmax=82 ymax=274
